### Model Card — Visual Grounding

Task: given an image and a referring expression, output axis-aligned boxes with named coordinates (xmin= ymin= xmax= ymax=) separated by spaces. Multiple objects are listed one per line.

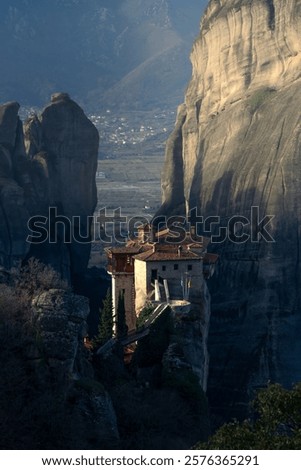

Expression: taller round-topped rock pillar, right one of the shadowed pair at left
xmin=25 ymin=93 xmax=99 ymax=281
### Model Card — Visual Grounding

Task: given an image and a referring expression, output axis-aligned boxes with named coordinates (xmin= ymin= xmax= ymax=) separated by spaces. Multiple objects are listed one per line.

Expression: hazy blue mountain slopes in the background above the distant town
xmin=0 ymin=0 xmax=207 ymax=112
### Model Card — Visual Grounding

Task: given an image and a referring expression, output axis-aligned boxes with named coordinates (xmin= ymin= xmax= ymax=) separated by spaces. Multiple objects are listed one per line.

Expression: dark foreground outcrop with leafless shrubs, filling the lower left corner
xmin=0 ymin=276 xmax=119 ymax=449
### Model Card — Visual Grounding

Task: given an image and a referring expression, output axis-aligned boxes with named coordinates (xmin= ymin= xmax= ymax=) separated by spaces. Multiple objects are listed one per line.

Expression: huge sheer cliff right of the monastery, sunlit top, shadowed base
xmin=160 ymin=0 xmax=301 ymax=413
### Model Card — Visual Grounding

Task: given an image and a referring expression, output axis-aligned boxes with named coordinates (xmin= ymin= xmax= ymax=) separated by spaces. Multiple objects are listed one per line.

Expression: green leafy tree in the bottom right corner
xmin=195 ymin=383 xmax=301 ymax=450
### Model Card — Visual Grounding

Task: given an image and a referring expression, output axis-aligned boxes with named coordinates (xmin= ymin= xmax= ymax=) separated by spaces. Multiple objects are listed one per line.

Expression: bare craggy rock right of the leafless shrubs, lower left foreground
xmin=32 ymin=289 xmax=119 ymax=449
